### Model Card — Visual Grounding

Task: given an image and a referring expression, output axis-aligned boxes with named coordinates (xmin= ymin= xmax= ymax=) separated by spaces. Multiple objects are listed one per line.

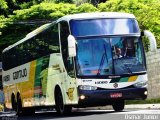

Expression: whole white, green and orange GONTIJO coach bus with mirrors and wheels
xmin=2 ymin=12 xmax=156 ymax=114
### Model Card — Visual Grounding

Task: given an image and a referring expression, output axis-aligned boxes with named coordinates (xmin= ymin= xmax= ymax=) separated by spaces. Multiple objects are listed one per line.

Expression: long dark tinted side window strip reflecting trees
xmin=3 ymin=24 xmax=60 ymax=70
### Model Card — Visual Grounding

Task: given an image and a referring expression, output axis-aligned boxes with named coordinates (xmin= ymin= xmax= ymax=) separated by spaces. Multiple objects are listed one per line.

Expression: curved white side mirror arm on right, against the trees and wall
xmin=141 ymin=30 xmax=157 ymax=51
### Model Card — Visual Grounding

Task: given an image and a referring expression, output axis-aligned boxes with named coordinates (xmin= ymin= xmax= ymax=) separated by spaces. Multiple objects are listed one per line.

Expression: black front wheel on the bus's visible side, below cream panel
xmin=55 ymin=89 xmax=72 ymax=115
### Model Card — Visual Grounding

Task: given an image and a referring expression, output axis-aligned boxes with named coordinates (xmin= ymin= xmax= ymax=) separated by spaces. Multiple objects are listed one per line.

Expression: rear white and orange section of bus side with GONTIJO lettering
xmin=3 ymin=61 xmax=36 ymax=108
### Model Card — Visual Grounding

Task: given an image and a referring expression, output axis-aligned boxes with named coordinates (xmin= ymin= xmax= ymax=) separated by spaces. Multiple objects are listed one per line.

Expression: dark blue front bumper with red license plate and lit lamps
xmin=79 ymin=88 xmax=147 ymax=107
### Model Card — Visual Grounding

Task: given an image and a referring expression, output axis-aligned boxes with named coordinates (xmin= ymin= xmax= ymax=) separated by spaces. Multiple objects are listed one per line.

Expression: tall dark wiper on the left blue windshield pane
xmin=97 ymin=44 xmax=108 ymax=75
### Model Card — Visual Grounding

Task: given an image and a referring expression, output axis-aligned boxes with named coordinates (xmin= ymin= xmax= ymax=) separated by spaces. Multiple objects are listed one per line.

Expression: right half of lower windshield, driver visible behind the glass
xmin=111 ymin=37 xmax=145 ymax=74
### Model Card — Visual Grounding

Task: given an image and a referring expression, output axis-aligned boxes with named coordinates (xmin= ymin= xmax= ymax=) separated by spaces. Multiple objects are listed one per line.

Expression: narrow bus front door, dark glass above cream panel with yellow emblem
xmin=60 ymin=21 xmax=77 ymax=103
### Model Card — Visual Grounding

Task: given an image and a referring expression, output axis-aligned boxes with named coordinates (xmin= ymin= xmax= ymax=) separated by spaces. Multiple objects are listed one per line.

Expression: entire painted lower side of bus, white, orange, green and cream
xmin=3 ymin=53 xmax=77 ymax=108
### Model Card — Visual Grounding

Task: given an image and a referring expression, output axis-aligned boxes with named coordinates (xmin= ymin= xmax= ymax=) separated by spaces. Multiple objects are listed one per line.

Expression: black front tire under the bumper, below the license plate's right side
xmin=112 ymin=100 xmax=125 ymax=112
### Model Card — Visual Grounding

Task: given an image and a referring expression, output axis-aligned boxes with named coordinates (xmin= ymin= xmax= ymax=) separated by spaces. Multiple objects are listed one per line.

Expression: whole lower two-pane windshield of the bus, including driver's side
xmin=76 ymin=36 xmax=145 ymax=76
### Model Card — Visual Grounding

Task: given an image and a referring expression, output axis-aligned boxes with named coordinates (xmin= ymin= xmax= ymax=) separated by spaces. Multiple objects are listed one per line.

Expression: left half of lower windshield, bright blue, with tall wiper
xmin=77 ymin=38 xmax=112 ymax=75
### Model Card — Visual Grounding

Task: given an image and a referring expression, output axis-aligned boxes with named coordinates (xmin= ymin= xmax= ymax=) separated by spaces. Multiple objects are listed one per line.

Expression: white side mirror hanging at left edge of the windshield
xmin=68 ymin=35 xmax=76 ymax=57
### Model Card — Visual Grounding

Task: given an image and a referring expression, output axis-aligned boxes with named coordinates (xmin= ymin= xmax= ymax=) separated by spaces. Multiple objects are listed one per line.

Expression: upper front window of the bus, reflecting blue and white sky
xmin=70 ymin=18 xmax=139 ymax=37
